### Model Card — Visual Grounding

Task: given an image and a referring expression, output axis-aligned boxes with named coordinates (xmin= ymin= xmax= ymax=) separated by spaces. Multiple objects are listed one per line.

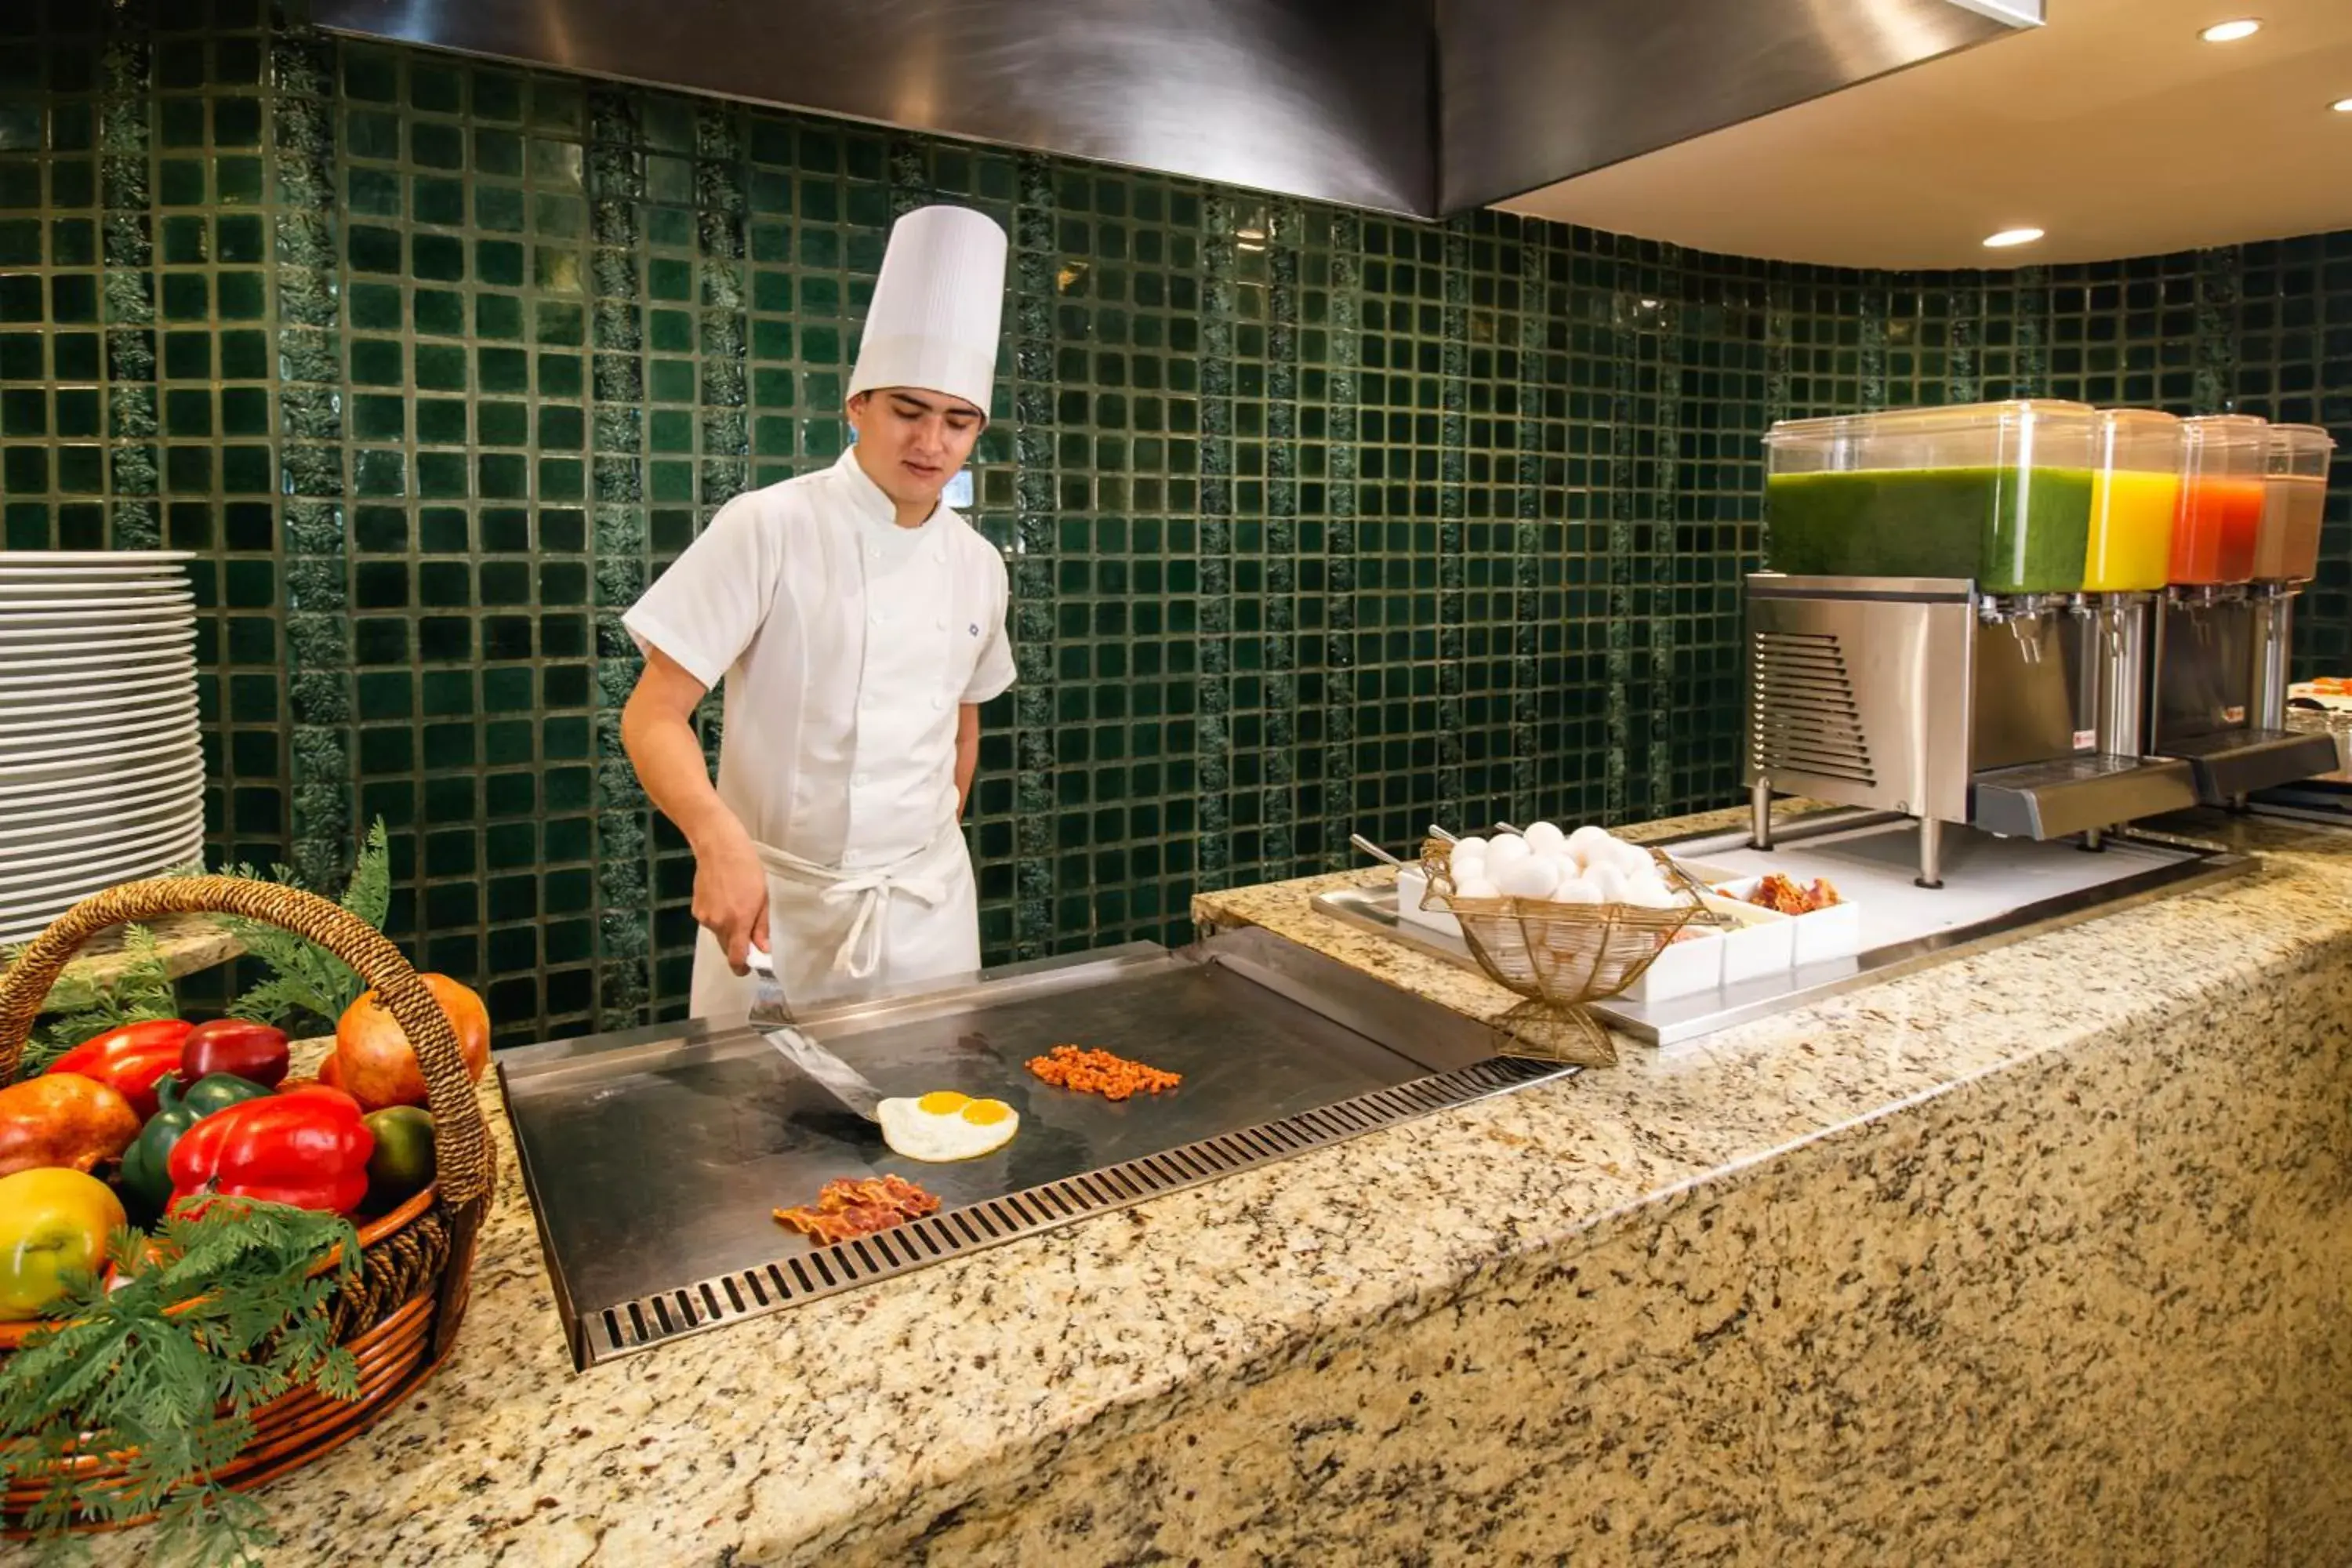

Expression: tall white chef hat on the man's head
xmin=849 ymin=207 xmax=1007 ymax=414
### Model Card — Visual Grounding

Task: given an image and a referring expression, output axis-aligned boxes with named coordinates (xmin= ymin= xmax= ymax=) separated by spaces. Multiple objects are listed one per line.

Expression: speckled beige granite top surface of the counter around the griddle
xmin=78 ymin=813 xmax=2352 ymax=1563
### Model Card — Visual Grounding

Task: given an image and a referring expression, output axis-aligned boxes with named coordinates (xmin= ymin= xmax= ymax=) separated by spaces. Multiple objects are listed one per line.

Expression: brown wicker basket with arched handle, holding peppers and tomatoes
xmin=0 ymin=877 xmax=494 ymax=1535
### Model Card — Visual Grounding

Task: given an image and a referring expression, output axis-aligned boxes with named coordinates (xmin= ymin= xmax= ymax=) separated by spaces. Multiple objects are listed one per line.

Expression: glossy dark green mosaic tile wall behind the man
xmin=0 ymin=0 xmax=2352 ymax=1041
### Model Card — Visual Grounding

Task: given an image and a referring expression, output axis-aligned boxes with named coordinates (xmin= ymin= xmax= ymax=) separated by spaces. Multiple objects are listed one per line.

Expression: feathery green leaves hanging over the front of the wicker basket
xmin=0 ymin=1199 xmax=360 ymax=1568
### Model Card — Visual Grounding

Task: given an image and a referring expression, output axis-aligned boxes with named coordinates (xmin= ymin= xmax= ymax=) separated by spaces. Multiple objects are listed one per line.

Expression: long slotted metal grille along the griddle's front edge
xmin=579 ymin=1055 xmax=1576 ymax=1366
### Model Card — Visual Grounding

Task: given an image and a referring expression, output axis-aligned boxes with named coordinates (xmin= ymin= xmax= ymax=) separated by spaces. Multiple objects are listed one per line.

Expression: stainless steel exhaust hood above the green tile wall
xmin=313 ymin=0 xmax=2042 ymax=216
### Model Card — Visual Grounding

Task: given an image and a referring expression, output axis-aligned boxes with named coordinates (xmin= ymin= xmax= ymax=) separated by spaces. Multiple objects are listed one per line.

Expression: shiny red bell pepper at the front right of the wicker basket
xmin=172 ymin=1083 xmax=376 ymax=1213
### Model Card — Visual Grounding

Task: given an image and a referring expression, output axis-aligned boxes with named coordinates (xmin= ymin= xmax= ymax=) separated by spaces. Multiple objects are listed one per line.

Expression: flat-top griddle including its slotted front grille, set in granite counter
xmin=499 ymin=931 xmax=1564 ymax=1366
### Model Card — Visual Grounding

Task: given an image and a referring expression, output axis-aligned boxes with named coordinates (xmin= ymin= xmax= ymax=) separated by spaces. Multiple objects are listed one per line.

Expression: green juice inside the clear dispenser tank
xmin=1764 ymin=468 xmax=2091 ymax=593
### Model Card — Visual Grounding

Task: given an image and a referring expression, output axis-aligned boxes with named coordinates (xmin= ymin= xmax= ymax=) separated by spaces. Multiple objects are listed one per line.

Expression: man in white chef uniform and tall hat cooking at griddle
xmin=621 ymin=207 xmax=1014 ymax=1018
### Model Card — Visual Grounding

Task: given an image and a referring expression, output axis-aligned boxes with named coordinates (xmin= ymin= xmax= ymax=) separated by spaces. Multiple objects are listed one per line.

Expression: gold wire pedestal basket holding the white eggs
xmin=1421 ymin=839 xmax=1715 ymax=1067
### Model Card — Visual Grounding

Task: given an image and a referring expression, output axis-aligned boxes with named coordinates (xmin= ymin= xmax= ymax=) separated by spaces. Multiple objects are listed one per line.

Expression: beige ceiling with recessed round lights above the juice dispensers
xmin=1503 ymin=0 xmax=2352 ymax=268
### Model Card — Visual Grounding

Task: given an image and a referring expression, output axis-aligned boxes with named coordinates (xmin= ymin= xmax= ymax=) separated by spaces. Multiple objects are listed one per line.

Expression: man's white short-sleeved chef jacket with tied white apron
xmin=623 ymin=449 xmax=1016 ymax=1015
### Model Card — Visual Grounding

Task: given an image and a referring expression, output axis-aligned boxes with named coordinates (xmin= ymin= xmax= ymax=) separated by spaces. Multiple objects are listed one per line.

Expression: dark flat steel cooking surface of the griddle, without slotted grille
xmin=508 ymin=959 xmax=1430 ymax=1316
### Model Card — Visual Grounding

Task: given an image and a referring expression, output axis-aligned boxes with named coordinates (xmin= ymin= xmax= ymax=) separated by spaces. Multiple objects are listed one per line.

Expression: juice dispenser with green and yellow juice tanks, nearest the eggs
xmin=1748 ymin=402 xmax=2194 ymax=886
